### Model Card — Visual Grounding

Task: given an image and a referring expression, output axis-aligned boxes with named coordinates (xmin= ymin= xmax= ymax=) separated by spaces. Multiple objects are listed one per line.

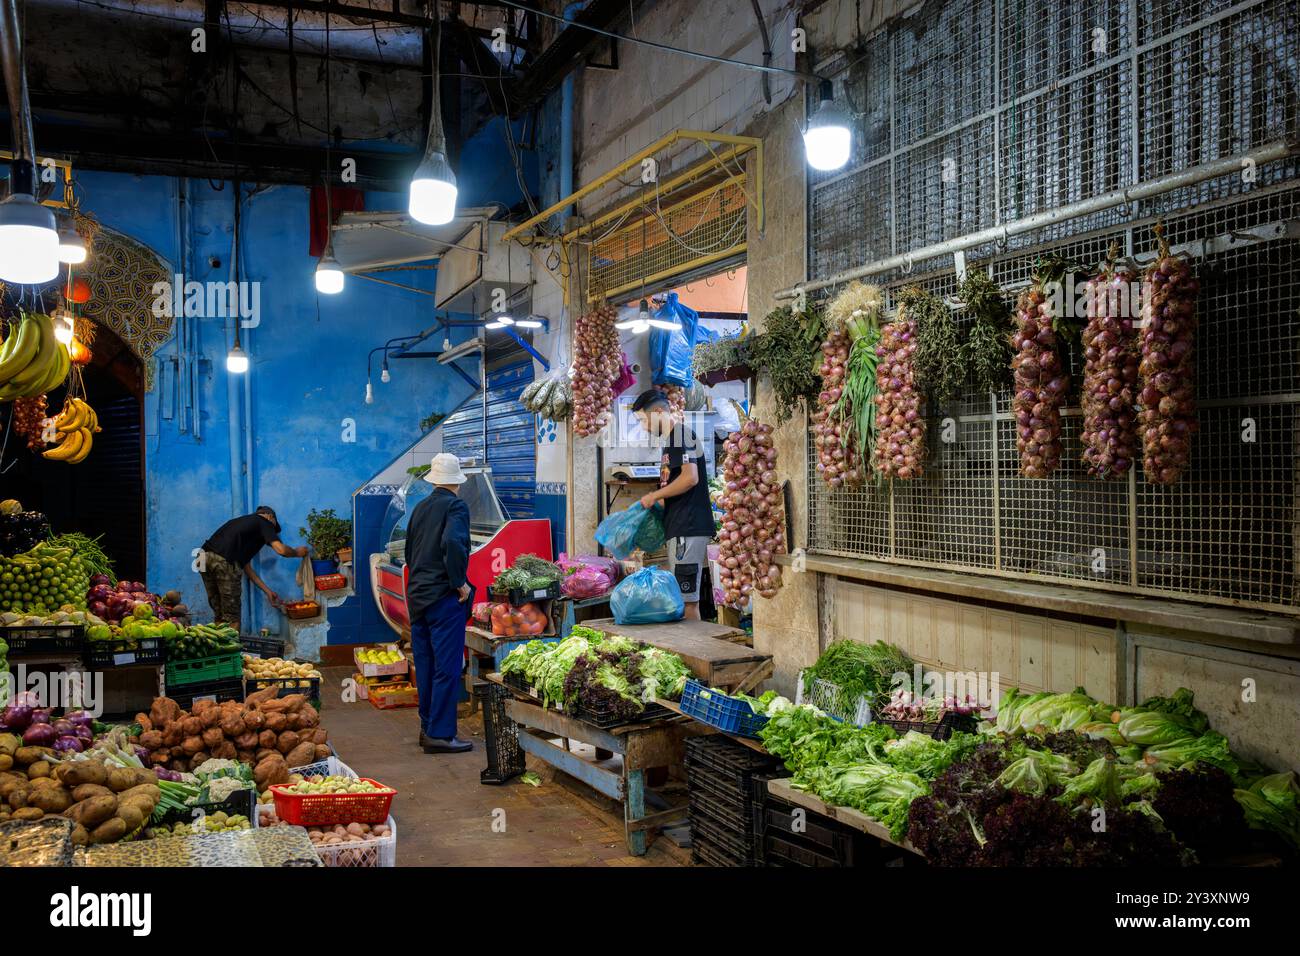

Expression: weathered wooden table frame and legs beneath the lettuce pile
xmin=485 ymin=674 xmax=712 ymax=856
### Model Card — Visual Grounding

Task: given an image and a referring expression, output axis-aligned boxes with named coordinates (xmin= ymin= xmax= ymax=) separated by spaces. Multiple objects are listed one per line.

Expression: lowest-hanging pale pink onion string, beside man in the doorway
xmin=718 ymin=419 xmax=785 ymax=607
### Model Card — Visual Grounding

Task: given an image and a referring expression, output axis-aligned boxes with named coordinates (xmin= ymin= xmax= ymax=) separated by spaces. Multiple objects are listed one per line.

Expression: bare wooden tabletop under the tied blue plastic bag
xmin=584 ymin=618 xmax=772 ymax=692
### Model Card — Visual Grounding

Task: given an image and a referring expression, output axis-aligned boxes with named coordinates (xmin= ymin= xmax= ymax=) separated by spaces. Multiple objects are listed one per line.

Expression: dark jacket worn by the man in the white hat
xmin=406 ymin=488 xmax=469 ymax=623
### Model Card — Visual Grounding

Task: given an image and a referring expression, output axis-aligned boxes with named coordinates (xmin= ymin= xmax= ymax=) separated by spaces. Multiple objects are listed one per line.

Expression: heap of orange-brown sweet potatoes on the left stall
xmin=135 ymin=687 xmax=329 ymax=790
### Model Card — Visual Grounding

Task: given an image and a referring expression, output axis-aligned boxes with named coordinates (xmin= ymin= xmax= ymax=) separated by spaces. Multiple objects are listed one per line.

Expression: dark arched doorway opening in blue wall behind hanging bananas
xmin=0 ymin=325 xmax=146 ymax=580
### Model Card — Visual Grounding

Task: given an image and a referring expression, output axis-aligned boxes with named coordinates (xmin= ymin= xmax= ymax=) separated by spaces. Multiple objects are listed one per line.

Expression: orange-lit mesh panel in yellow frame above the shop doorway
xmin=588 ymin=176 xmax=748 ymax=302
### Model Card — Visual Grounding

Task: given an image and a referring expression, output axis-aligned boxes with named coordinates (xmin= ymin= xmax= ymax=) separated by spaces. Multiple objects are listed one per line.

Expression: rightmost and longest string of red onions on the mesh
xmin=1138 ymin=228 xmax=1200 ymax=485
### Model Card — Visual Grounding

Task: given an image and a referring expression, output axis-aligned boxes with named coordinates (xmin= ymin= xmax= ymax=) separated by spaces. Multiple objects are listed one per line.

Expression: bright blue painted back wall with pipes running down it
xmin=79 ymin=126 xmax=536 ymax=642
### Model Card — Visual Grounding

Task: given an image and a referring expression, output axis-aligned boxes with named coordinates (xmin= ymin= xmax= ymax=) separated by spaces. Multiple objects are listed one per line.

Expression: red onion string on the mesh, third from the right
xmin=1011 ymin=282 xmax=1070 ymax=479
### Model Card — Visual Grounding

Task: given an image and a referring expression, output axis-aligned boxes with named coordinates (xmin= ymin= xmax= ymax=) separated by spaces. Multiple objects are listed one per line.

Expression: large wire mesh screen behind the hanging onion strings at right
xmin=809 ymin=0 xmax=1300 ymax=613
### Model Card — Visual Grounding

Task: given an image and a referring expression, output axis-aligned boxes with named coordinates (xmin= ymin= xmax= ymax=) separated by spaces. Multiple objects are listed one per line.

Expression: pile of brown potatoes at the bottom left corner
xmin=0 ymin=749 xmax=163 ymax=845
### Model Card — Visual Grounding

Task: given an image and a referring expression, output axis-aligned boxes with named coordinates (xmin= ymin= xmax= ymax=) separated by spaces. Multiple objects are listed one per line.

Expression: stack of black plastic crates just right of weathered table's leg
xmin=685 ymin=734 xmax=780 ymax=866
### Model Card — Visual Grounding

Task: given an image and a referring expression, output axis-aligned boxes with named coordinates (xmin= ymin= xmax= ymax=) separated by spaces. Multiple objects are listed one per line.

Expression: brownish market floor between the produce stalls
xmin=321 ymin=667 xmax=690 ymax=866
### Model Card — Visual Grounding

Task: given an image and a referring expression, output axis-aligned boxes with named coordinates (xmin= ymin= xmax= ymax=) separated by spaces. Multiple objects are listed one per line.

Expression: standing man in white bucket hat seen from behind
xmin=406 ymin=453 xmax=473 ymax=753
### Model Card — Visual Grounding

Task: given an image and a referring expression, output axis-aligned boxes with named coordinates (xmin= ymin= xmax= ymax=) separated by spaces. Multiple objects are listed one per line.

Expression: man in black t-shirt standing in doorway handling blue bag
xmin=632 ymin=389 xmax=714 ymax=620
